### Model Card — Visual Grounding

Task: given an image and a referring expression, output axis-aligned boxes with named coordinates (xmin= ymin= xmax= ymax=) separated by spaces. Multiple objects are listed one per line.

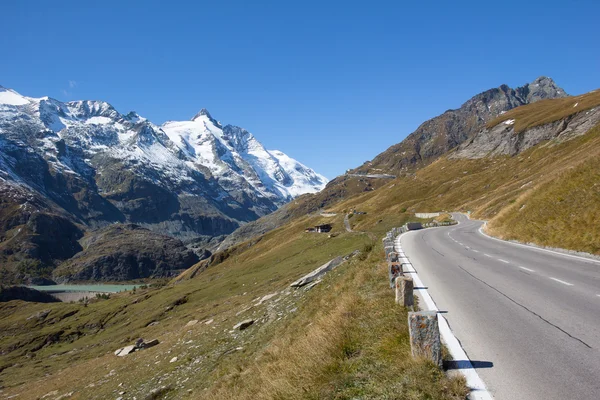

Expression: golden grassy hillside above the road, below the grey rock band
xmin=298 ymin=117 xmax=600 ymax=254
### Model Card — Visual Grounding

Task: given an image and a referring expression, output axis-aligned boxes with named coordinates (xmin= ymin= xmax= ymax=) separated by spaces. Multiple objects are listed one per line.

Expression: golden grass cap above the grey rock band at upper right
xmin=487 ymin=90 xmax=600 ymax=132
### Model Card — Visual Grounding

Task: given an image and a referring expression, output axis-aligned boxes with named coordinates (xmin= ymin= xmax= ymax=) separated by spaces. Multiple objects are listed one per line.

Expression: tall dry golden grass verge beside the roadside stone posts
xmin=207 ymin=245 xmax=467 ymax=400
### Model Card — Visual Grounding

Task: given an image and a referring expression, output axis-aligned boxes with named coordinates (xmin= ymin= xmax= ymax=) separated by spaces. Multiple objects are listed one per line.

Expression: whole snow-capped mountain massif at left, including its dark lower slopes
xmin=0 ymin=87 xmax=327 ymax=282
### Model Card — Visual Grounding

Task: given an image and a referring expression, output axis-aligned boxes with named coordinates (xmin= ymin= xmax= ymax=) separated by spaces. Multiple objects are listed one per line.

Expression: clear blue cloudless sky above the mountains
xmin=0 ymin=0 xmax=600 ymax=178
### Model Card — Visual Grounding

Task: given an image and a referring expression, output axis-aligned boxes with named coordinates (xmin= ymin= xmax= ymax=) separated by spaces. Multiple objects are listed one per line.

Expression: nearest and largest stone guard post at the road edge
xmin=408 ymin=311 xmax=442 ymax=367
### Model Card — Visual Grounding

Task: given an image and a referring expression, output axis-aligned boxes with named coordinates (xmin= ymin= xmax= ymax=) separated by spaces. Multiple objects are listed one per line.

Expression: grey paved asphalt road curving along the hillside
xmin=401 ymin=214 xmax=600 ymax=400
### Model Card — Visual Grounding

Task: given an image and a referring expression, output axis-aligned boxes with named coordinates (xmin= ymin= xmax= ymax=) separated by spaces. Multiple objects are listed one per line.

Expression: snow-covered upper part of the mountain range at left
xmin=0 ymin=88 xmax=327 ymax=209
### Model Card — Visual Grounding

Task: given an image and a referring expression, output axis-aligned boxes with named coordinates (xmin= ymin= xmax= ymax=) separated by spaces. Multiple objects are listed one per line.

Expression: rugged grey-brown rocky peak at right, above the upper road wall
xmin=351 ymin=76 xmax=567 ymax=174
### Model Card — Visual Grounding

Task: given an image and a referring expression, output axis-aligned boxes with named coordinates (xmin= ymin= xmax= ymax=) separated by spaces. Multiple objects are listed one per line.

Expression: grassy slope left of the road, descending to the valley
xmin=0 ymin=211 xmax=465 ymax=399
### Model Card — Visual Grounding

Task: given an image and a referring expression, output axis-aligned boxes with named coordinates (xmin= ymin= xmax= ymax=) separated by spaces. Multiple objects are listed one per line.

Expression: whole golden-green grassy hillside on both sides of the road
xmin=0 ymin=87 xmax=600 ymax=399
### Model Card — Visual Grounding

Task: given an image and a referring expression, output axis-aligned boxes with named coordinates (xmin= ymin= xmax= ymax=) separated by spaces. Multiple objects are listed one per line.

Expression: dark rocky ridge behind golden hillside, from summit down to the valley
xmin=219 ymin=77 xmax=571 ymax=250
